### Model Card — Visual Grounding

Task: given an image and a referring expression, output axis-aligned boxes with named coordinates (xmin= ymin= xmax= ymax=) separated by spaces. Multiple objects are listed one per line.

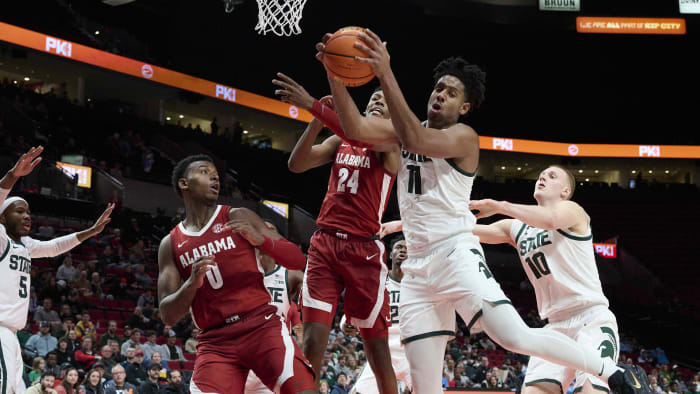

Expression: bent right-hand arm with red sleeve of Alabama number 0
xmin=224 ymin=208 xmax=306 ymax=270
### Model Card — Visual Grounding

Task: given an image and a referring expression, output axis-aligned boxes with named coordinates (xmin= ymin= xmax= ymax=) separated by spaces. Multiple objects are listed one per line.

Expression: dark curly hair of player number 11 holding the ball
xmin=433 ymin=56 xmax=486 ymax=112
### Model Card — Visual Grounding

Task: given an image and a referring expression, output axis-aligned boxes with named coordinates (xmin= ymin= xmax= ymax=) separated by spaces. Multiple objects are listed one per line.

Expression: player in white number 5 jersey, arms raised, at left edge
xmin=0 ymin=146 xmax=113 ymax=394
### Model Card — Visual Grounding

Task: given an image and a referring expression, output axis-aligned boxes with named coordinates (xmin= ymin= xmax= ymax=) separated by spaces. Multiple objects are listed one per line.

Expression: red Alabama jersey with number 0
xmin=170 ymin=205 xmax=270 ymax=330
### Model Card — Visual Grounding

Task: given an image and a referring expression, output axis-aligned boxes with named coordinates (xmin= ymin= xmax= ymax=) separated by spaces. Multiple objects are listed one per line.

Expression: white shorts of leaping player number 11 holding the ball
xmin=399 ymin=235 xmax=510 ymax=344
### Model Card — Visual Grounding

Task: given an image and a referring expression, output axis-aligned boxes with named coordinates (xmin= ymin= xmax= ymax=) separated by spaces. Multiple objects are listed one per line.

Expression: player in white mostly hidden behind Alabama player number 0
xmin=245 ymin=221 xmax=304 ymax=394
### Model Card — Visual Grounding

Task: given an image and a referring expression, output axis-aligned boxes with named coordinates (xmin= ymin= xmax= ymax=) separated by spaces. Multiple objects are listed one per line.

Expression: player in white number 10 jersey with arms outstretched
xmin=470 ymin=165 xmax=652 ymax=394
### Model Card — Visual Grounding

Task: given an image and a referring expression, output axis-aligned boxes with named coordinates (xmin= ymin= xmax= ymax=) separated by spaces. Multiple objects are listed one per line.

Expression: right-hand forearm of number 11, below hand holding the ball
xmin=379 ymin=72 xmax=424 ymax=151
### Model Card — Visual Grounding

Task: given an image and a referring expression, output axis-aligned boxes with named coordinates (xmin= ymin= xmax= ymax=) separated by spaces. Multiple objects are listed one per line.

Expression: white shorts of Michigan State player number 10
xmin=525 ymin=306 xmax=620 ymax=393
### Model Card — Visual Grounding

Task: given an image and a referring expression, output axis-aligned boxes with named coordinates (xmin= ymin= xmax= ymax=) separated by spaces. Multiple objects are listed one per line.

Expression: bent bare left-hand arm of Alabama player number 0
xmin=158 ymin=235 xmax=216 ymax=326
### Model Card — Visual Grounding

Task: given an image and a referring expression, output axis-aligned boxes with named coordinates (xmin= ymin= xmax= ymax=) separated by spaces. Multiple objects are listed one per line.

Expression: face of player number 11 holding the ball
xmin=428 ymin=75 xmax=470 ymax=127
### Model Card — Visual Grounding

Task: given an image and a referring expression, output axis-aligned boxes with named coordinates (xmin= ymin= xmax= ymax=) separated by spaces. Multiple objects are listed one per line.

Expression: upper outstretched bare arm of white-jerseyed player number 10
xmin=469 ymin=199 xmax=588 ymax=233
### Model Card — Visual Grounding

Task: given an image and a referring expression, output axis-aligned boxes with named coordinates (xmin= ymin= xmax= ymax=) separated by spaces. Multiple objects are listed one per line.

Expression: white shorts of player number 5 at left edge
xmin=0 ymin=326 xmax=27 ymax=394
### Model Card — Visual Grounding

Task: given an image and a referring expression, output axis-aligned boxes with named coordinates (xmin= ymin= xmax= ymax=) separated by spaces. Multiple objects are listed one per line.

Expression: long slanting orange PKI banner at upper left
xmin=0 ymin=22 xmax=312 ymax=122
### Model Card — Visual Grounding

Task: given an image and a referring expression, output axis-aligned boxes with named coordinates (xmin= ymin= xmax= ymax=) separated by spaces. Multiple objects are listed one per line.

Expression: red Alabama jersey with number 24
xmin=316 ymin=141 xmax=396 ymax=238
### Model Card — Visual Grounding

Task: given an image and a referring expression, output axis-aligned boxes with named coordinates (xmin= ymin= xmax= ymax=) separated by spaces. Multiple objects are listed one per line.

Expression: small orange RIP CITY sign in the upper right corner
xmin=576 ymin=16 xmax=685 ymax=34
